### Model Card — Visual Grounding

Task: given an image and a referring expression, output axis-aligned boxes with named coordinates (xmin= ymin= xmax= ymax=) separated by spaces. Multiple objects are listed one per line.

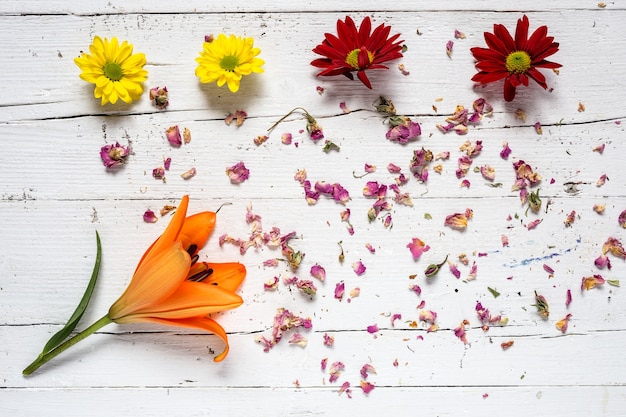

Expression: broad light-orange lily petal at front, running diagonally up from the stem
xmin=109 ymin=242 xmax=191 ymax=323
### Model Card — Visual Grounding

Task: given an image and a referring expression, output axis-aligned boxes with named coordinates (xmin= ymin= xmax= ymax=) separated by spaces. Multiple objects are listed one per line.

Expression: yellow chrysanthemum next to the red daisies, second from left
xmin=196 ymin=33 xmax=265 ymax=93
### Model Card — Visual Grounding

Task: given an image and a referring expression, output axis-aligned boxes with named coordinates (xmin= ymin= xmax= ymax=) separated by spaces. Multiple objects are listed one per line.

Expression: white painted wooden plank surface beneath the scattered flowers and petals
xmin=0 ymin=0 xmax=626 ymax=417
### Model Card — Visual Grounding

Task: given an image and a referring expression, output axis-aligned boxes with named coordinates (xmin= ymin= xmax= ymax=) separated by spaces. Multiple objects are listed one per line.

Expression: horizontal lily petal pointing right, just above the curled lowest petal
xmin=125 ymin=281 xmax=243 ymax=322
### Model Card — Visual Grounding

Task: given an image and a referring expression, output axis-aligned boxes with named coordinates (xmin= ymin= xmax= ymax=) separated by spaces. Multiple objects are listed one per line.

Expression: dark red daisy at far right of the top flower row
xmin=471 ymin=15 xmax=561 ymax=101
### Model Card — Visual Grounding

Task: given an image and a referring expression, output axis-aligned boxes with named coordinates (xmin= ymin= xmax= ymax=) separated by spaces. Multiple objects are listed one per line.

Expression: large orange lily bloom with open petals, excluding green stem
xmin=108 ymin=196 xmax=246 ymax=362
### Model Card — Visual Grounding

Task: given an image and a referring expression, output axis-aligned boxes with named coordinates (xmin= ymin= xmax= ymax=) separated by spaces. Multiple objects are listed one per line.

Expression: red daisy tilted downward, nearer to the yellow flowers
xmin=311 ymin=16 xmax=404 ymax=88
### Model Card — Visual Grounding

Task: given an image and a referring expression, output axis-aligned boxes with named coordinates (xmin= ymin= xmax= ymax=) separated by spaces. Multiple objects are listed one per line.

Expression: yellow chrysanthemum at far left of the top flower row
xmin=74 ymin=36 xmax=148 ymax=106
